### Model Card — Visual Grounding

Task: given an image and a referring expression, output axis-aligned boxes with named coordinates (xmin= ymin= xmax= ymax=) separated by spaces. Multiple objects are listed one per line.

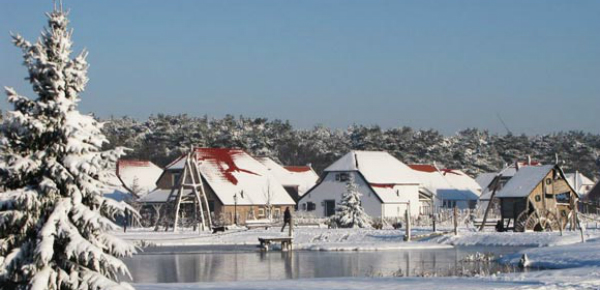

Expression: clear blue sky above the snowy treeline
xmin=0 ymin=0 xmax=600 ymax=134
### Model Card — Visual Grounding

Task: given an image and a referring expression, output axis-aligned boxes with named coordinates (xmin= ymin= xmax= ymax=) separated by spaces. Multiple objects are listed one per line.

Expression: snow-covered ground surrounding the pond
xmin=116 ymin=228 xmax=600 ymax=290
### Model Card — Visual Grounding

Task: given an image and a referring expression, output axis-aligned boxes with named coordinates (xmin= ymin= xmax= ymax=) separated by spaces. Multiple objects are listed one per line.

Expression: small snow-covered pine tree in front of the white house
xmin=332 ymin=174 xmax=371 ymax=228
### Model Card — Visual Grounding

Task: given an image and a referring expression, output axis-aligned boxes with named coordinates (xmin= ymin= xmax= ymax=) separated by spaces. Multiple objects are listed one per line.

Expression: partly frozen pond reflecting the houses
xmin=125 ymin=246 xmax=523 ymax=283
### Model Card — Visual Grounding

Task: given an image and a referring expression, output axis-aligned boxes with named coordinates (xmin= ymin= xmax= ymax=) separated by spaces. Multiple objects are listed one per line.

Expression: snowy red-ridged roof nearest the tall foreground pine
xmin=117 ymin=160 xmax=163 ymax=196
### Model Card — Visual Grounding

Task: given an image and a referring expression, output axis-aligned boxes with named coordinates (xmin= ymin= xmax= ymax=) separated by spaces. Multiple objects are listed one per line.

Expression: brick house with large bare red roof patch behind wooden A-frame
xmin=138 ymin=148 xmax=296 ymax=224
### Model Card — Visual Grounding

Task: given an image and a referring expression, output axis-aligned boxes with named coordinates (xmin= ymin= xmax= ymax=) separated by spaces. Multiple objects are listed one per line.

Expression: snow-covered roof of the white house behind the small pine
xmin=325 ymin=151 xmax=419 ymax=185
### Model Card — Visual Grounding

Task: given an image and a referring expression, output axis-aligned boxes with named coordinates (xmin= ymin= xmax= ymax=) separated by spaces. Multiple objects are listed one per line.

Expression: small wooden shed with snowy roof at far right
xmin=496 ymin=165 xmax=578 ymax=231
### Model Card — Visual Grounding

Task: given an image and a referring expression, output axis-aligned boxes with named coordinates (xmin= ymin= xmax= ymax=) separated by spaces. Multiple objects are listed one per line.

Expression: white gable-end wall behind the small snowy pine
xmin=298 ymin=172 xmax=382 ymax=217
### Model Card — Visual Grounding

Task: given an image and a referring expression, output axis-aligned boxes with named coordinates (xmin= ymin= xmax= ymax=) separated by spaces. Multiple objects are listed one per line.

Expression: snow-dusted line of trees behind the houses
xmin=104 ymin=115 xmax=600 ymax=178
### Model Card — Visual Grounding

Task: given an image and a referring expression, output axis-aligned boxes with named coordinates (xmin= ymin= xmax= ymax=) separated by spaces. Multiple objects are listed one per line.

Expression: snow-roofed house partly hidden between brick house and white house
xmin=256 ymin=157 xmax=319 ymax=202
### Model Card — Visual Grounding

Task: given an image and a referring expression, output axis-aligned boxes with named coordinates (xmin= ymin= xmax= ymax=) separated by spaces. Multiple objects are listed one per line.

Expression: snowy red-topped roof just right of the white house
xmin=410 ymin=164 xmax=481 ymax=200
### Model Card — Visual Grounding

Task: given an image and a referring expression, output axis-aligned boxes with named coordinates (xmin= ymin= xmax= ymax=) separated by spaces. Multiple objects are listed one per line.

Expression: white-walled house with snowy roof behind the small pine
xmin=298 ymin=151 xmax=420 ymax=217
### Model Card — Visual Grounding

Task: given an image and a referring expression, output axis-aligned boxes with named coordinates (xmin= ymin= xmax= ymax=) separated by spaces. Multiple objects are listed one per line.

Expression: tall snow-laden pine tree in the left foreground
xmin=0 ymin=8 xmax=135 ymax=290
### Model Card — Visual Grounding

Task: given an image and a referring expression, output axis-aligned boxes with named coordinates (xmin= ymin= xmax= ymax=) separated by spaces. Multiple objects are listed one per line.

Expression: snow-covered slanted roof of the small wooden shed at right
xmin=496 ymin=165 xmax=554 ymax=197
